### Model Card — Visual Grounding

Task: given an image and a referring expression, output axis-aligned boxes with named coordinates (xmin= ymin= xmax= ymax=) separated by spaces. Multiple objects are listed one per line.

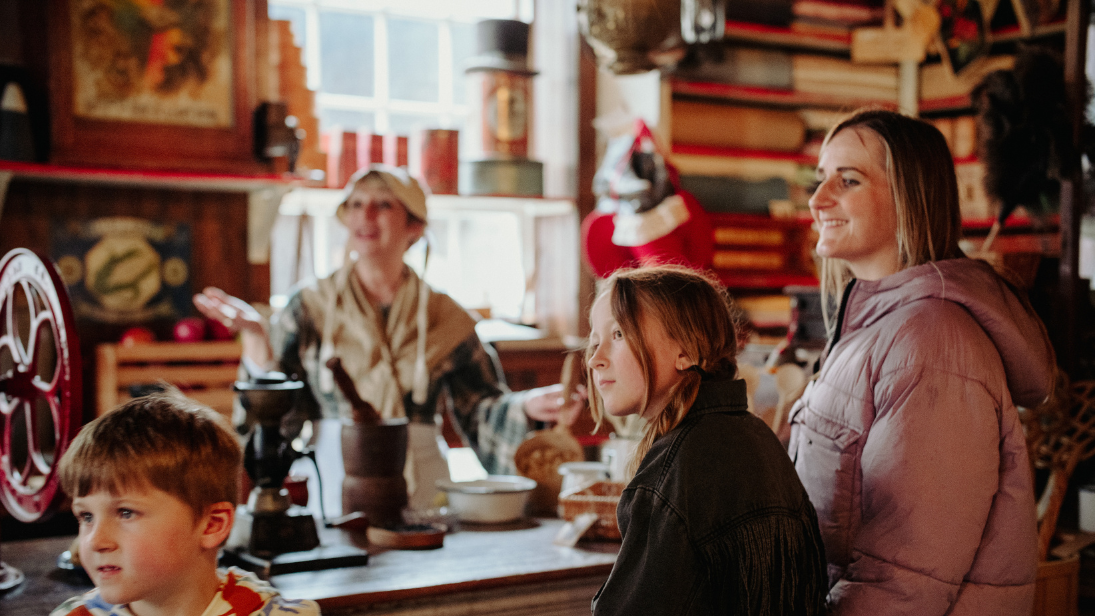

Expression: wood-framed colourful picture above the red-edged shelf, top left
xmin=49 ymin=0 xmax=267 ymax=173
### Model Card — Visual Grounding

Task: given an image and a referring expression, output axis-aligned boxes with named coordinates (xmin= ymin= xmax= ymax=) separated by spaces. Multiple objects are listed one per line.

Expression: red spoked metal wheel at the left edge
xmin=0 ymin=248 xmax=83 ymax=522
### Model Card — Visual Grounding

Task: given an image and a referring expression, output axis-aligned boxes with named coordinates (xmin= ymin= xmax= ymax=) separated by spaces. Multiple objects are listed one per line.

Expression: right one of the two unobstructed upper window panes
xmin=388 ymin=19 xmax=439 ymax=103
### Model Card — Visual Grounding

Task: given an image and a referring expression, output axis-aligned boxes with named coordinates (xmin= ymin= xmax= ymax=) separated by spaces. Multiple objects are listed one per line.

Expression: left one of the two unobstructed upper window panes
xmin=320 ymin=11 xmax=373 ymax=96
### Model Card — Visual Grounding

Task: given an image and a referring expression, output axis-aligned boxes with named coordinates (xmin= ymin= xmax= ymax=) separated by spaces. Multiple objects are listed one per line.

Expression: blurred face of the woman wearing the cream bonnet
xmin=343 ymin=178 xmax=425 ymax=258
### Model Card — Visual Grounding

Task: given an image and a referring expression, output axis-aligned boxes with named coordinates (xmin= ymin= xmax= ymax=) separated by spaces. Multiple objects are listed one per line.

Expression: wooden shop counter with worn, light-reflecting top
xmin=0 ymin=520 xmax=619 ymax=616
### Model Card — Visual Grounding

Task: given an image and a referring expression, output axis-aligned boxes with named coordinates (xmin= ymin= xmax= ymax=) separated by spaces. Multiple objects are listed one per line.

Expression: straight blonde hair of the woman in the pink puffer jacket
xmin=821 ymin=108 xmax=964 ymax=323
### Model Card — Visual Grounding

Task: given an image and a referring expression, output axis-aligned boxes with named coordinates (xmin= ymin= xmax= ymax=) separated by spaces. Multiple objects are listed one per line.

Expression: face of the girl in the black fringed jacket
xmin=588 ymin=293 xmax=688 ymax=417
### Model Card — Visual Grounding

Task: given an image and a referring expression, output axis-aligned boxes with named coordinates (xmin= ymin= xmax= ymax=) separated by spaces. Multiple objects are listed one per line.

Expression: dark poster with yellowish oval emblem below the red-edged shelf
xmin=49 ymin=217 xmax=191 ymax=324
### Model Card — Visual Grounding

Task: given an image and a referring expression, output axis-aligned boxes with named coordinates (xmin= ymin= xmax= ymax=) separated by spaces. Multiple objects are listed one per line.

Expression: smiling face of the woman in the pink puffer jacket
xmin=810 ymin=128 xmax=901 ymax=280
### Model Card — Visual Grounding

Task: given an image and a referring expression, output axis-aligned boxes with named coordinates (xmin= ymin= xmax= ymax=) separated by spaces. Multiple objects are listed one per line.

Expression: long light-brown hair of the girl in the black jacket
xmin=586 ymin=265 xmax=738 ymax=475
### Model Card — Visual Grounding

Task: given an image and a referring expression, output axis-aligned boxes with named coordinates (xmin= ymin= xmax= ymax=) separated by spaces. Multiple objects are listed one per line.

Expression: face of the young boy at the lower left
xmin=72 ymin=487 xmax=222 ymax=614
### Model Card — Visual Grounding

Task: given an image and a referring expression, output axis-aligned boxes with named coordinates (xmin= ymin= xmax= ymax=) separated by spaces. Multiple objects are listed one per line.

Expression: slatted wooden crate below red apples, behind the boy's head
xmin=95 ymin=341 xmax=242 ymax=417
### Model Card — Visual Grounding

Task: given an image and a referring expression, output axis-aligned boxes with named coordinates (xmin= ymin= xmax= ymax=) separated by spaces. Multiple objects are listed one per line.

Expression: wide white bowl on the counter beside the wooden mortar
xmin=437 ymin=475 xmax=537 ymax=524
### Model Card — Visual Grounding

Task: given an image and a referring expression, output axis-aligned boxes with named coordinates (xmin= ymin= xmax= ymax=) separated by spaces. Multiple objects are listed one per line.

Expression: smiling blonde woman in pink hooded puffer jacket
xmin=789 ymin=111 xmax=1054 ymax=616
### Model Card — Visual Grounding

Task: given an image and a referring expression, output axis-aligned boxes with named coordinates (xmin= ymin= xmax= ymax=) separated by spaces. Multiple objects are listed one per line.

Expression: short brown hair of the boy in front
xmin=59 ymin=386 xmax=243 ymax=515
